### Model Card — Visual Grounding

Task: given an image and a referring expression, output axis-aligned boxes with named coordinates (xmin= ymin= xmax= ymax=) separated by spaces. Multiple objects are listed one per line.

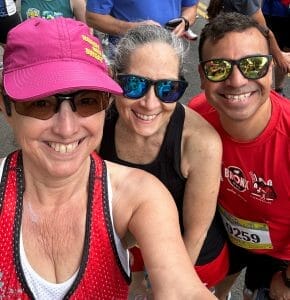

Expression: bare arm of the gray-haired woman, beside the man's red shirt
xmin=182 ymin=107 xmax=222 ymax=264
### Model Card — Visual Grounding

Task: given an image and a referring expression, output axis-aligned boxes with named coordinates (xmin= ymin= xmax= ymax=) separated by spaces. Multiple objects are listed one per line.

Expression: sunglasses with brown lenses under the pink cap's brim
xmin=4 ymin=91 xmax=109 ymax=120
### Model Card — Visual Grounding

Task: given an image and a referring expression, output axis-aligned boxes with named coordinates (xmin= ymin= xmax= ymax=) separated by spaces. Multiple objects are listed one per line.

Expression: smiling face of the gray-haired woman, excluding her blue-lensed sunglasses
xmin=116 ymin=42 xmax=179 ymax=137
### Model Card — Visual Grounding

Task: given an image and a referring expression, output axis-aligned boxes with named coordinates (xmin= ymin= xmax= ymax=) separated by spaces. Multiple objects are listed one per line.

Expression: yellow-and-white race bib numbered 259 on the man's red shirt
xmin=219 ymin=206 xmax=273 ymax=249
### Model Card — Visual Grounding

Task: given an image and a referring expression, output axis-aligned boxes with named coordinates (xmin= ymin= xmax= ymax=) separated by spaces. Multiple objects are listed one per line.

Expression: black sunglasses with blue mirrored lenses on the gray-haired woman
xmin=117 ymin=74 xmax=188 ymax=103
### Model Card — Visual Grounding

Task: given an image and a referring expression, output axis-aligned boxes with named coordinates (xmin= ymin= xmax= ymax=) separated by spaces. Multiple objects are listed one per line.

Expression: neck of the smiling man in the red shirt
xmin=220 ymin=99 xmax=272 ymax=142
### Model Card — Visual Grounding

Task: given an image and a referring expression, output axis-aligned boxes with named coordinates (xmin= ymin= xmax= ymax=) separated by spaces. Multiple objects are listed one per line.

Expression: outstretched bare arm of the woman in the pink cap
xmin=113 ymin=164 xmax=216 ymax=300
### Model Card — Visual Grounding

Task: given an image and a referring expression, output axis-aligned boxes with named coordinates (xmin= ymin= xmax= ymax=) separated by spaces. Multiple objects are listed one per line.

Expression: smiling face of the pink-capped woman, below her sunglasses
xmin=0 ymin=94 xmax=105 ymax=179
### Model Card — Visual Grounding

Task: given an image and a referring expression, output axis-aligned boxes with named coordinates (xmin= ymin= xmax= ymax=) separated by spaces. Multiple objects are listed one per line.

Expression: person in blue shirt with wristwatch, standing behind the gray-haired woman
xmin=86 ymin=0 xmax=198 ymax=56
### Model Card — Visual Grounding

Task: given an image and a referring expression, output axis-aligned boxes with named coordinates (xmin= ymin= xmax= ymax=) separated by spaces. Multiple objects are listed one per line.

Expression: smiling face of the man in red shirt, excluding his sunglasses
xmin=199 ymin=28 xmax=272 ymax=127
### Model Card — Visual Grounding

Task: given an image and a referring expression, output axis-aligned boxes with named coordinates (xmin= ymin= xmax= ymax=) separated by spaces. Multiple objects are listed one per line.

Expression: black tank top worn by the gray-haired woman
xmin=100 ymin=102 xmax=225 ymax=265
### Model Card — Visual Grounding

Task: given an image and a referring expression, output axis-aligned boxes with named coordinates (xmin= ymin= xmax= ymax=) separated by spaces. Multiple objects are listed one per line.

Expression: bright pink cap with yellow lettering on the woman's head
xmin=3 ymin=17 xmax=122 ymax=101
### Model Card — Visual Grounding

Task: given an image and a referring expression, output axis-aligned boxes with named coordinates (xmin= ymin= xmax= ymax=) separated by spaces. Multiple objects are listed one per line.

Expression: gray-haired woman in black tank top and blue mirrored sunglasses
xmin=100 ymin=25 xmax=228 ymax=296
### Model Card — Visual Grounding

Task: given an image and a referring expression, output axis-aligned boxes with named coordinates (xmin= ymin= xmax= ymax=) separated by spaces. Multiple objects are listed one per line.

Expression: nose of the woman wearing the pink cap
xmin=53 ymin=101 xmax=80 ymax=138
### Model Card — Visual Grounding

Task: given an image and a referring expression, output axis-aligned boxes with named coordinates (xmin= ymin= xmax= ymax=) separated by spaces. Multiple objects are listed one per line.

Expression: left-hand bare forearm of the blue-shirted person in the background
xmin=86 ymin=10 xmax=160 ymax=36
